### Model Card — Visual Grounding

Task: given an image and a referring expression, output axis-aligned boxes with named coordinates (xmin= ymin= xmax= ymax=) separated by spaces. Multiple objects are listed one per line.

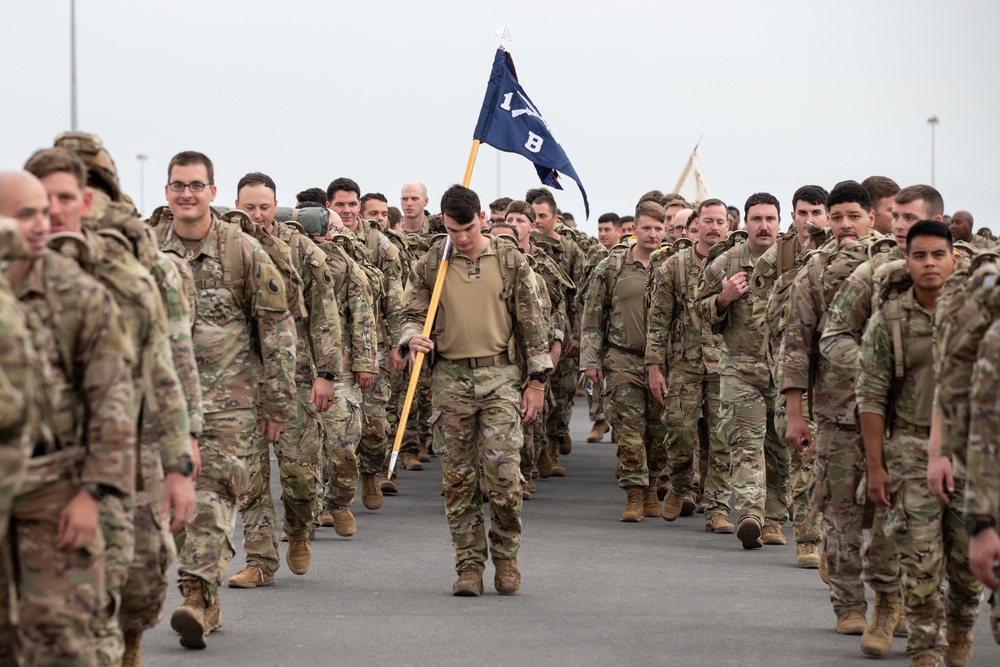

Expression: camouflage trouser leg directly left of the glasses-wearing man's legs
xmin=118 ymin=491 xmax=177 ymax=631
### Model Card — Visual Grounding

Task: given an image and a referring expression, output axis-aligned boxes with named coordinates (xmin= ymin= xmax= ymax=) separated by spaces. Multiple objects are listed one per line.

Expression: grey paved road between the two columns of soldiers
xmin=144 ymin=399 xmax=1000 ymax=667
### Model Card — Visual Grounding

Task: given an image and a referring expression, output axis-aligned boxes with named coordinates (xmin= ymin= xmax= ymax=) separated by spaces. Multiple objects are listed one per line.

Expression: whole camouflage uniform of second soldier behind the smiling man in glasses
xmin=315 ymin=237 xmax=378 ymax=517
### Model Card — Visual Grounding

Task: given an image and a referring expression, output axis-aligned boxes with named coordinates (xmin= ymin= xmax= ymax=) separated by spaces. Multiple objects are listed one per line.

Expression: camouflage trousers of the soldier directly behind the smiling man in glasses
xmin=240 ymin=386 xmax=323 ymax=575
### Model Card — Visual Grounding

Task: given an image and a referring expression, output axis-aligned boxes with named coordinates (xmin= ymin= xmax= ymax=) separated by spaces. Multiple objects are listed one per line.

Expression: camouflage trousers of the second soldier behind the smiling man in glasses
xmin=314 ymin=378 xmax=362 ymax=522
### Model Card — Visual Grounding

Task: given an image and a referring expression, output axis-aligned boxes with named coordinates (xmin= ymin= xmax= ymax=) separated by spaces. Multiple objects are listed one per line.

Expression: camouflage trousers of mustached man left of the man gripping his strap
xmin=663 ymin=367 xmax=732 ymax=516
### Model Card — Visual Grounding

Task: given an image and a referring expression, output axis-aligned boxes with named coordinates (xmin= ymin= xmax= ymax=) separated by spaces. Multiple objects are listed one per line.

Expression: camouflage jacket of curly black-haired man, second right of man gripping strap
xmin=778 ymin=237 xmax=872 ymax=426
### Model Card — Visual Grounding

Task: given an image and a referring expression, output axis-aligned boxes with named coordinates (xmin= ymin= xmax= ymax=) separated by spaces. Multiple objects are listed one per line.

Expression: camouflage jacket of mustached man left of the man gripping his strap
xmin=646 ymin=246 xmax=722 ymax=375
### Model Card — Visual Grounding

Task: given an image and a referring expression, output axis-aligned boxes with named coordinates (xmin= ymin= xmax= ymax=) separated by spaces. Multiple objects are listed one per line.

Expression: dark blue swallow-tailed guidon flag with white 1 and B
xmin=472 ymin=49 xmax=590 ymax=218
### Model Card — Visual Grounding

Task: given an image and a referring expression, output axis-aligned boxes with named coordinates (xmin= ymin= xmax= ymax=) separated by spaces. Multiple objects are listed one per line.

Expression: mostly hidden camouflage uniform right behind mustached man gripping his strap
xmin=750 ymin=227 xmax=825 ymax=544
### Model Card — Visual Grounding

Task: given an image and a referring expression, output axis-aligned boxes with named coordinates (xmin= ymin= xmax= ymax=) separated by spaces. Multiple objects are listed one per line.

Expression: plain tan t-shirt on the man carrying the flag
xmin=434 ymin=247 xmax=513 ymax=359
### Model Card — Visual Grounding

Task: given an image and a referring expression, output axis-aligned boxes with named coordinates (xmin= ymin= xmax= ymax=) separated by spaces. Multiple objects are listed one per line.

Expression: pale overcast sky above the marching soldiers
xmin=0 ymin=0 xmax=1000 ymax=233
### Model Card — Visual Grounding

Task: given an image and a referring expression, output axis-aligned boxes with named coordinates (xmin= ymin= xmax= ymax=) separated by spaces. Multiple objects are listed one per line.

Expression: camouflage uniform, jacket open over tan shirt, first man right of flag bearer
xmin=580 ymin=246 xmax=666 ymax=489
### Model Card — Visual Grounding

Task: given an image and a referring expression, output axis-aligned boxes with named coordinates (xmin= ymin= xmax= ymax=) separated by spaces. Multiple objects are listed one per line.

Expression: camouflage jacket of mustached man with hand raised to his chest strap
xmin=695 ymin=242 xmax=774 ymax=387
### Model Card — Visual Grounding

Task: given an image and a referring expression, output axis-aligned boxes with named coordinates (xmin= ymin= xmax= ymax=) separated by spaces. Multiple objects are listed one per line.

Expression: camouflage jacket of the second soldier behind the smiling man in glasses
xmin=319 ymin=241 xmax=378 ymax=379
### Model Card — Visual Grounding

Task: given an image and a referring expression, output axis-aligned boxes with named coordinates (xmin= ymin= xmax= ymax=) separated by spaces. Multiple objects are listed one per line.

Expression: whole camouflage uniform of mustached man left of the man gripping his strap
xmin=646 ymin=246 xmax=732 ymax=519
